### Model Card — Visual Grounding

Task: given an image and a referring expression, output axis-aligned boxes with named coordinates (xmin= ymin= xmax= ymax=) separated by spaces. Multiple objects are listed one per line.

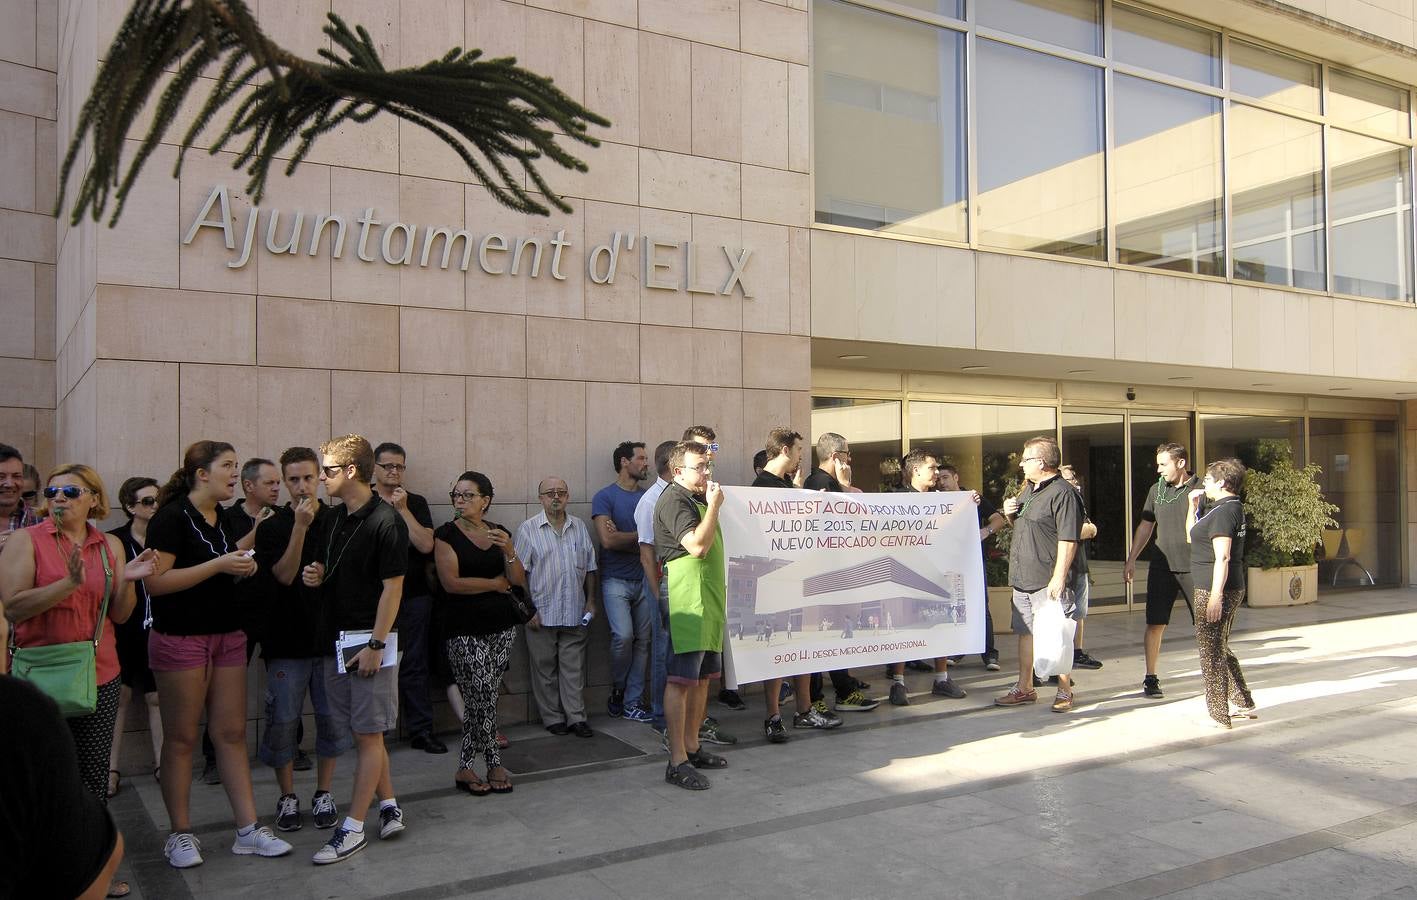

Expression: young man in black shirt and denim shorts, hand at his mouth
xmin=255 ymin=446 xmax=345 ymax=831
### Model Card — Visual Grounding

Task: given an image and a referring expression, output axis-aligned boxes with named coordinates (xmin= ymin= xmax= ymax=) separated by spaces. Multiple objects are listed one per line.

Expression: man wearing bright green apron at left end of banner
xmin=655 ymin=441 xmax=728 ymax=791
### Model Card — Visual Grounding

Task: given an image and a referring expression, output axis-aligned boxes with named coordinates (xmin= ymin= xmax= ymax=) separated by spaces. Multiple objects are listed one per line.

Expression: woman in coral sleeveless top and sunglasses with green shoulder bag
xmin=0 ymin=465 xmax=154 ymax=897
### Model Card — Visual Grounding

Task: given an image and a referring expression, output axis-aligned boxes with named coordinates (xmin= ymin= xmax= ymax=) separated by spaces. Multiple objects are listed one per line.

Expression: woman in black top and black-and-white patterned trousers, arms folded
xmin=434 ymin=472 xmax=527 ymax=797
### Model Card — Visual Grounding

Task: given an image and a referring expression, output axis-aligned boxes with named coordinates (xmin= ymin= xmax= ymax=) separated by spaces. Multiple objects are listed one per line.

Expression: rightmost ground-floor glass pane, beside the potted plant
xmin=1309 ymin=418 xmax=1401 ymax=588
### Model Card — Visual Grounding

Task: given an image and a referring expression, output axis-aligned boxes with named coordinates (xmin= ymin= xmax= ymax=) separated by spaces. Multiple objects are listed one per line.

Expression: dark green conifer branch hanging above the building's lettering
xmin=54 ymin=0 xmax=609 ymax=227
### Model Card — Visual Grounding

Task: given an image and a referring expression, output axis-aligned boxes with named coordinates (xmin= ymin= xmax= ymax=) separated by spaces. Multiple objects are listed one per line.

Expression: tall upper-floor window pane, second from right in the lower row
xmin=1230 ymin=103 xmax=1328 ymax=291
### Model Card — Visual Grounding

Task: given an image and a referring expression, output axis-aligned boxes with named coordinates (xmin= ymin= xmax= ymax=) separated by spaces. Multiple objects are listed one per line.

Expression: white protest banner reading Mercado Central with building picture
xmin=718 ymin=488 xmax=988 ymax=683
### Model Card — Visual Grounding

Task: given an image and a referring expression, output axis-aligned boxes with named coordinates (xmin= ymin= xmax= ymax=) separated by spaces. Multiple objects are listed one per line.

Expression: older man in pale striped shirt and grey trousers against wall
xmin=516 ymin=475 xmax=597 ymax=737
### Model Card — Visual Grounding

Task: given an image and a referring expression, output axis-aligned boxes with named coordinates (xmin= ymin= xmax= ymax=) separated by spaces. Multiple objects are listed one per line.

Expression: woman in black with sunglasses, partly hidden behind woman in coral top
xmin=108 ymin=476 xmax=163 ymax=798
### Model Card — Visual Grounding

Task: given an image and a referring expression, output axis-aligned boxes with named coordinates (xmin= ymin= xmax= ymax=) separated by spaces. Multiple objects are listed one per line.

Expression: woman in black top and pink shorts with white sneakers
xmin=147 ymin=441 xmax=290 ymax=869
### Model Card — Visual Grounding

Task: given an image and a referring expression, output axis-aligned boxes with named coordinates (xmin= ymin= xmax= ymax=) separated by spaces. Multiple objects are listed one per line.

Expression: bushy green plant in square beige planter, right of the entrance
xmin=1244 ymin=458 xmax=1338 ymax=607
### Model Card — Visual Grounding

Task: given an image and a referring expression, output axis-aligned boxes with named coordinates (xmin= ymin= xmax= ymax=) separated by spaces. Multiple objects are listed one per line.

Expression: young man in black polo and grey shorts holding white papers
xmin=300 ymin=435 xmax=408 ymax=866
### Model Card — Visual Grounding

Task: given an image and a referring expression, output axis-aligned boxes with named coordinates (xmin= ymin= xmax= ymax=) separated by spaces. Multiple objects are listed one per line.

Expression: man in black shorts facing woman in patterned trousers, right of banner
xmin=1122 ymin=444 xmax=1200 ymax=697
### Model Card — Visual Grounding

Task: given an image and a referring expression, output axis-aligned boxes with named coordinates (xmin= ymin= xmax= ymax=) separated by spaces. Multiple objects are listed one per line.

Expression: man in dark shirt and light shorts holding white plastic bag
xmin=993 ymin=437 xmax=1083 ymax=713
